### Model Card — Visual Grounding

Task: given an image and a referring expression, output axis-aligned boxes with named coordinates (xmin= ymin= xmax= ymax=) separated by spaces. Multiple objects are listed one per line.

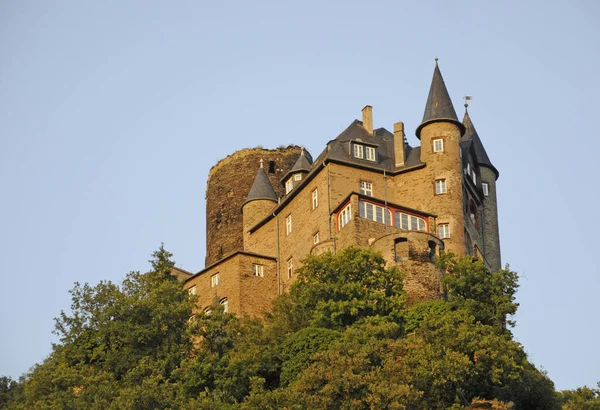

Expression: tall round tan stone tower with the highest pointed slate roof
xmin=416 ymin=58 xmax=465 ymax=254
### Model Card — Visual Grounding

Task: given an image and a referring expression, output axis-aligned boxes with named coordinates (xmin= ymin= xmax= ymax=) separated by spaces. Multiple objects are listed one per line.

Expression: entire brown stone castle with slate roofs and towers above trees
xmin=175 ymin=59 xmax=501 ymax=316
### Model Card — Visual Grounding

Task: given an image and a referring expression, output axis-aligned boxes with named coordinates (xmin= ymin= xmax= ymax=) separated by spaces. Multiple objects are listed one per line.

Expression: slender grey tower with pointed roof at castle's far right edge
xmin=463 ymin=108 xmax=502 ymax=272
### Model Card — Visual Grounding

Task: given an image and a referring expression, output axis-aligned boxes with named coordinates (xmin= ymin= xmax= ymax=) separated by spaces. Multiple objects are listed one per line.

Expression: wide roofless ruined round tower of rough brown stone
xmin=205 ymin=145 xmax=301 ymax=266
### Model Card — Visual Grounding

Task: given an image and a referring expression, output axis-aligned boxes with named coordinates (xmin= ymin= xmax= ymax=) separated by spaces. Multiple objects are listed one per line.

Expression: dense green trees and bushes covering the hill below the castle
xmin=0 ymin=246 xmax=600 ymax=409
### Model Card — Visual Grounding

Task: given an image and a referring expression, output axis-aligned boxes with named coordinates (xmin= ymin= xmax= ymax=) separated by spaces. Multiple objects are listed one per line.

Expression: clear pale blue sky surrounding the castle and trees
xmin=0 ymin=0 xmax=600 ymax=389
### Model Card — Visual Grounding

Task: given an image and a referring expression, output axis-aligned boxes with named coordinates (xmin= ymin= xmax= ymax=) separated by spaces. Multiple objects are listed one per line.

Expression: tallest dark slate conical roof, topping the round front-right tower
xmin=416 ymin=58 xmax=465 ymax=139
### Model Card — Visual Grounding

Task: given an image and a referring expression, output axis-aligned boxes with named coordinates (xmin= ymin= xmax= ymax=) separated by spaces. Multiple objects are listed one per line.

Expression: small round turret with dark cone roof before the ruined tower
xmin=242 ymin=159 xmax=278 ymax=248
